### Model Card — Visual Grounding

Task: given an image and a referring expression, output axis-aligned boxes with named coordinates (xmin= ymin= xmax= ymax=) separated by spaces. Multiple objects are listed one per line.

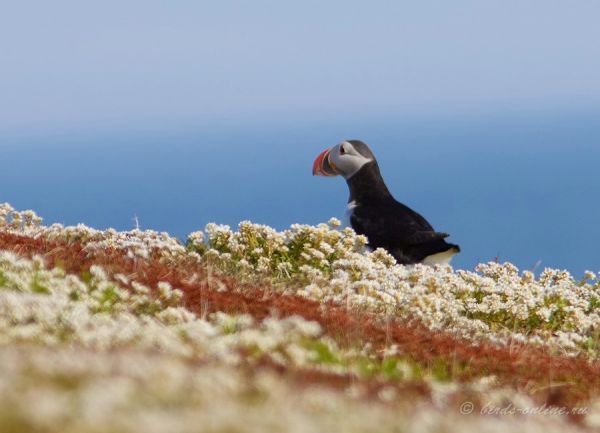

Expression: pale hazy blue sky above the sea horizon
xmin=0 ymin=0 xmax=600 ymax=134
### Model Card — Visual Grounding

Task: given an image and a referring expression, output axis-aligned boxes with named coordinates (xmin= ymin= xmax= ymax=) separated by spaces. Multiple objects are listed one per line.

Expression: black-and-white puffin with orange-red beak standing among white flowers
xmin=312 ymin=140 xmax=460 ymax=266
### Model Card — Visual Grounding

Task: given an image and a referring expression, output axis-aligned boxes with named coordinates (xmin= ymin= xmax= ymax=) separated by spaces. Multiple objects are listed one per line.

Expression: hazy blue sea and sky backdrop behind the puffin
xmin=0 ymin=0 xmax=600 ymax=276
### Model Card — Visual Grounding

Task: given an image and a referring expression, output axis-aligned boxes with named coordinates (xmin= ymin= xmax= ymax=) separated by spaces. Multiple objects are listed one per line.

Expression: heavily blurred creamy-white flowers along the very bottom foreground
xmin=0 ymin=346 xmax=596 ymax=433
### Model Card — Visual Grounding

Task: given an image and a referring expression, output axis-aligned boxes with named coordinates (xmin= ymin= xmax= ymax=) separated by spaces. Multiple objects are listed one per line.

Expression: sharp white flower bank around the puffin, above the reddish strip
xmin=195 ymin=220 xmax=600 ymax=354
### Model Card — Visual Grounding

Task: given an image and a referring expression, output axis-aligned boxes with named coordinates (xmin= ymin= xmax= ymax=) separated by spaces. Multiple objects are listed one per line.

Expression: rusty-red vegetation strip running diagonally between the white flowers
xmin=0 ymin=233 xmax=600 ymax=412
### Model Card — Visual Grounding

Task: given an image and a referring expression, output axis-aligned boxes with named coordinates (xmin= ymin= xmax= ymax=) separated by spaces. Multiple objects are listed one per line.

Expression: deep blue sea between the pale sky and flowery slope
xmin=0 ymin=111 xmax=600 ymax=276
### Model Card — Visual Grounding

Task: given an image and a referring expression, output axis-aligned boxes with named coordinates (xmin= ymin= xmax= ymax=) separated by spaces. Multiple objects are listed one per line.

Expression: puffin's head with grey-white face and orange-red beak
xmin=313 ymin=140 xmax=375 ymax=179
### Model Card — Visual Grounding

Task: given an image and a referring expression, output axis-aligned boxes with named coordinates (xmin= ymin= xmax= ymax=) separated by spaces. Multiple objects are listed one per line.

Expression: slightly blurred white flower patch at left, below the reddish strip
xmin=0 ymin=252 xmax=339 ymax=366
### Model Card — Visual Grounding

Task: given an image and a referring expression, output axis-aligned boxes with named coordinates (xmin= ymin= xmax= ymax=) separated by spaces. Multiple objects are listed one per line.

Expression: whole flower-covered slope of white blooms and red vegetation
xmin=0 ymin=204 xmax=600 ymax=433
